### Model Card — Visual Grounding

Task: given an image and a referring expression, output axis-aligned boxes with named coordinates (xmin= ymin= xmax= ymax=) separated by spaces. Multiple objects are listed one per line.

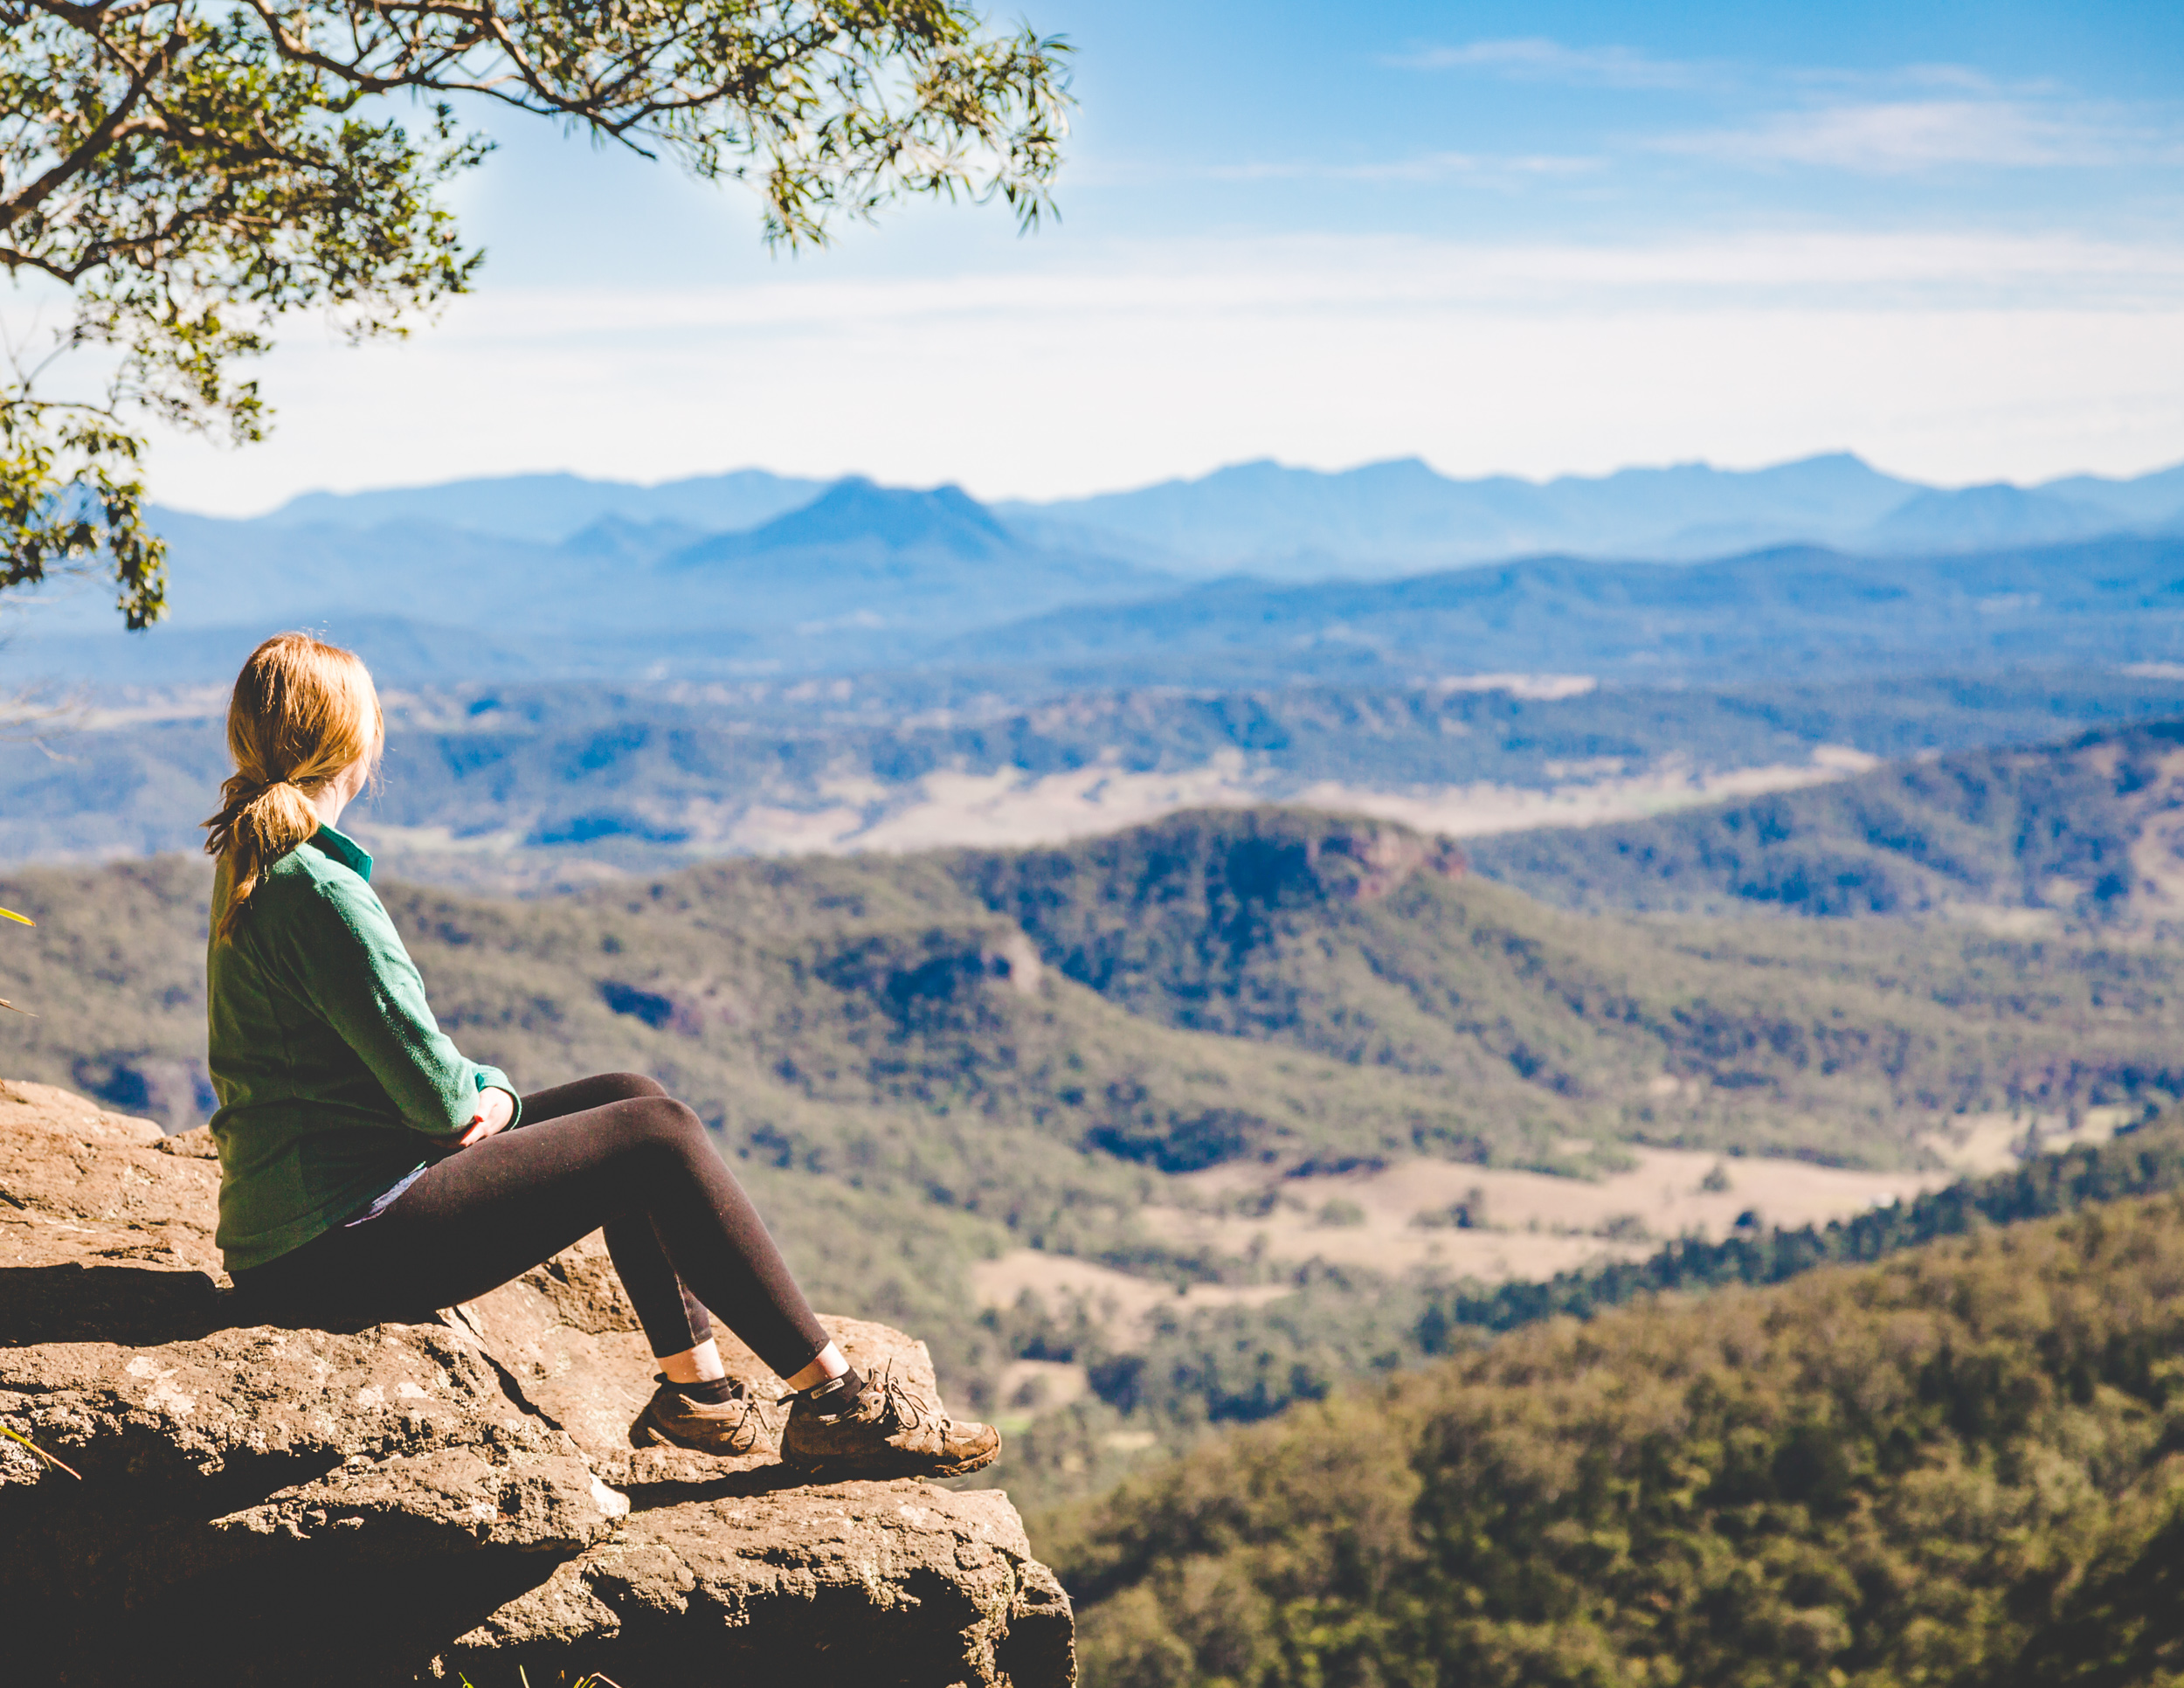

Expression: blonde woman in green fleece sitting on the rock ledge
xmin=205 ymin=633 xmax=1000 ymax=1478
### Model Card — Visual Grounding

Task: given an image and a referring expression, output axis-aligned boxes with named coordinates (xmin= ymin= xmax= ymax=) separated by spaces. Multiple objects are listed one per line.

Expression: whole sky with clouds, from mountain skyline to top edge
xmin=132 ymin=0 xmax=2184 ymax=511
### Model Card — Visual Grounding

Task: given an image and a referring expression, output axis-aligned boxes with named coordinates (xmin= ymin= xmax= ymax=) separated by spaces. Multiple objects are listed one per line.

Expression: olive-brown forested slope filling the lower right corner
xmin=1042 ymin=1197 xmax=2184 ymax=1688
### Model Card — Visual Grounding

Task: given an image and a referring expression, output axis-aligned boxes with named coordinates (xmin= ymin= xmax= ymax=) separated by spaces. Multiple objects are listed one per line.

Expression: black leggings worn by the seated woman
xmin=236 ymin=1072 xmax=828 ymax=1378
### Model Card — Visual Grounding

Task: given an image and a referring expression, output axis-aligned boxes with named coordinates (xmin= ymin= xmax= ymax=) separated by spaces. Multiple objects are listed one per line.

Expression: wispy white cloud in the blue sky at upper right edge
xmin=1654 ymin=98 xmax=2184 ymax=175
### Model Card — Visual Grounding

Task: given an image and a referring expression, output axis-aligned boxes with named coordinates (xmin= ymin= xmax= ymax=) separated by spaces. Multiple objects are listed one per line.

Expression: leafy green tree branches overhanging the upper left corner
xmin=0 ymin=0 xmax=1068 ymax=626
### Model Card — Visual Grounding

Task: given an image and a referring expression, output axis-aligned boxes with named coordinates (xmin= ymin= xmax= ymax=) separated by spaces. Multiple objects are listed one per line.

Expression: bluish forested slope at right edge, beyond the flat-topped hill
xmin=1472 ymin=721 xmax=2184 ymax=924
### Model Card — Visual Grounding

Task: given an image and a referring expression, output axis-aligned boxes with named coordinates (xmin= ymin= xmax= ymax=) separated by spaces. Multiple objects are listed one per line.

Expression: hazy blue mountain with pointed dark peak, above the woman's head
xmin=0 ymin=481 xmax=1178 ymax=683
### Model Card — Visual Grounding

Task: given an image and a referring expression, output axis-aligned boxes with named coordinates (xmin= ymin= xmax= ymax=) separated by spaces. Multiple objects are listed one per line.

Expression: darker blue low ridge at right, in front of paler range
xmin=946 ymin=537 xmax=2184 ymax=681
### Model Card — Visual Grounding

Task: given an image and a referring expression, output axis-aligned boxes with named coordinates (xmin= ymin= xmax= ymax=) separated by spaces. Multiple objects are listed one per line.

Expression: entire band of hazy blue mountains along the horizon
xmin=0 ymin=454 xmax=2184 ymax=683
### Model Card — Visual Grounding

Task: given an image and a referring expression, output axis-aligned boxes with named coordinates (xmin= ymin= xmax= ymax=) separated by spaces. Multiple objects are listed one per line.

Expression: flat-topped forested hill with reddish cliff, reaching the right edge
xmin=950 ymin=810 xmax=2184 ymax=1158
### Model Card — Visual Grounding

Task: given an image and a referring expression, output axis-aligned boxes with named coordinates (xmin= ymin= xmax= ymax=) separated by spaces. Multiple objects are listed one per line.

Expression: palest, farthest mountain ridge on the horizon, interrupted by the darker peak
xmin=247 ymin=452 xmax=2184 ymax=578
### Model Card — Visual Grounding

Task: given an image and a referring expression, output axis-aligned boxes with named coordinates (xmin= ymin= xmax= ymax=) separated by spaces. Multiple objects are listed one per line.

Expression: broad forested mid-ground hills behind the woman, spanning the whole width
xmin=0 ymin=810 xmax=2184 ymax=1441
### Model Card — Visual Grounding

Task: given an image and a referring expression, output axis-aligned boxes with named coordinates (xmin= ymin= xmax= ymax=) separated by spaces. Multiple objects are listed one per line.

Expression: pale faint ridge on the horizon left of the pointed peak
xmin=260 ymin=469 xmax=828 ymax=543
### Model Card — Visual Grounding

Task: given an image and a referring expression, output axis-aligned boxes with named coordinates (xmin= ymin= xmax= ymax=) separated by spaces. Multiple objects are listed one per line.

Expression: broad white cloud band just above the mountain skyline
xmin=114 ymin=233 xmax=2184 ymax=511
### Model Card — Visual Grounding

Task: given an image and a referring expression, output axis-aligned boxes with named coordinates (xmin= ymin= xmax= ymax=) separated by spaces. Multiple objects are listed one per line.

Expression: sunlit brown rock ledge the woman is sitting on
xmin=0 ymin=1085 xmax=1075 ymax=1688
